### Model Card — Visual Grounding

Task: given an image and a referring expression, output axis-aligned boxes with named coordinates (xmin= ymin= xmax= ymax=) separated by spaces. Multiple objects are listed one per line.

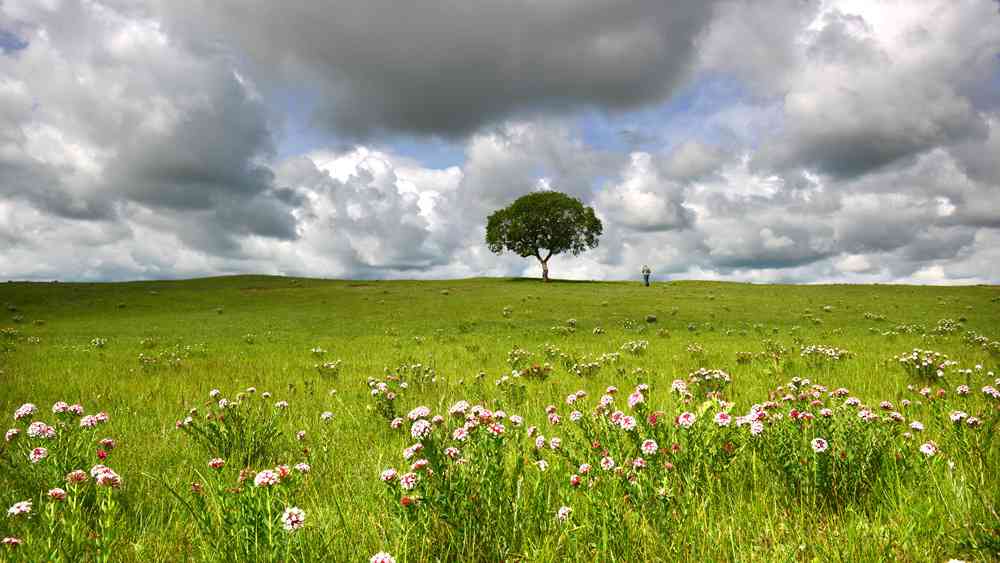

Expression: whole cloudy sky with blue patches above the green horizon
xmin=0 ymin=0 xmax=1000 ymax=283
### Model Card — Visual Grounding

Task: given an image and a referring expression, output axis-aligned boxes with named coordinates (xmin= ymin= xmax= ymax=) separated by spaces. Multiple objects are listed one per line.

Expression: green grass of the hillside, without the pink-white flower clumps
xmin=0 ymin=276 xmax=1000 ymax=561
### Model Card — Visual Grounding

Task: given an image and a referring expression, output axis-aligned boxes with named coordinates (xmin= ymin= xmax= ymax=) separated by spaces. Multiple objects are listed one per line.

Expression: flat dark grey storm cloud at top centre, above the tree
xmin=154 ymin=0 xmax=716 ymax=136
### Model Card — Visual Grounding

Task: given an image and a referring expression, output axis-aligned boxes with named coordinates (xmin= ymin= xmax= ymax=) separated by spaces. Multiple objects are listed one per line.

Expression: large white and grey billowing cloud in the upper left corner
xmin=0 ymin=1 xmax=295 ymax=252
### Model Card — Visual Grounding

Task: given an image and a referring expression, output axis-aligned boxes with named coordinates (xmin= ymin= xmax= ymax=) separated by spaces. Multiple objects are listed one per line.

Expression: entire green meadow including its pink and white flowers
xmin=0 ymin=276 xmax=1000 ymax=563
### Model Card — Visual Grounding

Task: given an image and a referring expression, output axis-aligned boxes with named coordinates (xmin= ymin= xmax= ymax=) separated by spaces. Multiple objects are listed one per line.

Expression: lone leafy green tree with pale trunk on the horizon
xmin=486 ymin=191 xmax=604 ymax=281
